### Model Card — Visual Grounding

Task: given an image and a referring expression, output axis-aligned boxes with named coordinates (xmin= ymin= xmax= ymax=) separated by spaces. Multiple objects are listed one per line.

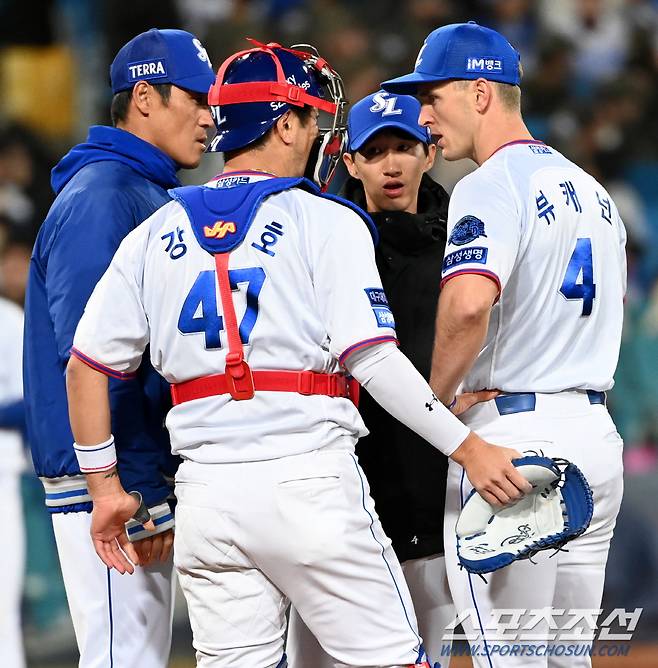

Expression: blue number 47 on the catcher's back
xmin=178 ymin=267 xmax=265 ymax=349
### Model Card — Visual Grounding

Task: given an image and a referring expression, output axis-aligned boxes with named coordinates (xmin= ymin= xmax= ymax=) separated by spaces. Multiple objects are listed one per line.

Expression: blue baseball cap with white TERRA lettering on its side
xmin=110 ymin=28 xmax=215 ymax=93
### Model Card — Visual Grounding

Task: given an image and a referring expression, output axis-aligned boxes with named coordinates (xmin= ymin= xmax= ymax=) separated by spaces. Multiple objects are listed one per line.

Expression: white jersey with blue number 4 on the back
xmin=443 ymin=141 xmax=626 ymax=392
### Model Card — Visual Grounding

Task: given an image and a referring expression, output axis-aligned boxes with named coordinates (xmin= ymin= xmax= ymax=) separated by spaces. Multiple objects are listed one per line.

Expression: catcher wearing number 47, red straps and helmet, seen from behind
xmin=67 ymin=43 xmax=528 ymax=668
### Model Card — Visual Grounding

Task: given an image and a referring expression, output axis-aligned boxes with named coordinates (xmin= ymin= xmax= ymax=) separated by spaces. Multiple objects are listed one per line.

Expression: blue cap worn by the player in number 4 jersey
xmin=382 ymin=21 xmax=521 ymax=95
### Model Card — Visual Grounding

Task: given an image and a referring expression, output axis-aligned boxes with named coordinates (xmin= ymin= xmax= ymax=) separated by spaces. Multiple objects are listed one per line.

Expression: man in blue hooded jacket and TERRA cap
xmin=24 ymin=29 xmax=214 ymax=668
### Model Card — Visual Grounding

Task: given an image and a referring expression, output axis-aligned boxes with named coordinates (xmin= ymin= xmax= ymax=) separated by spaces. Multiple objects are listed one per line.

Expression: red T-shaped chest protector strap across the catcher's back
xmin=171 ymin=253 xmax=359 ymax=406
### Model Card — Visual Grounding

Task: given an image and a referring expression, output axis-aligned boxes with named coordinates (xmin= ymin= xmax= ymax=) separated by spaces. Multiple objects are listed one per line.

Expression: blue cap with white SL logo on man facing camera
xmin=347 ymin=90 xmax=432 ymax=151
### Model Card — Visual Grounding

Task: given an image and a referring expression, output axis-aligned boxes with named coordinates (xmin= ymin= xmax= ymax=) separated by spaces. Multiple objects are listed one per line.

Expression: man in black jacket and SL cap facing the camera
xmin=286 ymin=91 xmax=462 ymax=668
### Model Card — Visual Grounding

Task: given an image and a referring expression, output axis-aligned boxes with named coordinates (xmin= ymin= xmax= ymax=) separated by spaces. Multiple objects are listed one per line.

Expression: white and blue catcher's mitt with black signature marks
xmin=457 ymin=456 xmax=594 ymax=573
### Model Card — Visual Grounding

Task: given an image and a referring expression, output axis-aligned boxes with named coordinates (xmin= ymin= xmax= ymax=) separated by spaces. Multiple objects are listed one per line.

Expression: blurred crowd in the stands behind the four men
xmin=0 ymin=0 xmax=658 ymax=665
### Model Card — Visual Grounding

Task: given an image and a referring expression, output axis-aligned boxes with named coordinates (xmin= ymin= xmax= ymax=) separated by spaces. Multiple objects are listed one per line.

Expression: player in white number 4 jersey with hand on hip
xmin=383 ymin=22 xmax=626 ymax=668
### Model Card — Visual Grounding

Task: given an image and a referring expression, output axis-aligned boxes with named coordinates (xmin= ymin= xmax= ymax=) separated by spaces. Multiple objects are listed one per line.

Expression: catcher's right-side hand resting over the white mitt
xmin=451 ymin=432 xmax=532 ymax=506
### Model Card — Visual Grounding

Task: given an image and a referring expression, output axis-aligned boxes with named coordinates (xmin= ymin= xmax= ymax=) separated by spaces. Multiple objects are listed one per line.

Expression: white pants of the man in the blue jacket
xmin=52 ymin=512 xmax=175 ymax=668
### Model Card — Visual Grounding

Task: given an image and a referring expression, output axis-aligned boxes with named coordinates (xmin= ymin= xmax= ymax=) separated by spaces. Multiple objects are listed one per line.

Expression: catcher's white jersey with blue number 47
xmin=74 ymin=173 xmax=395 ymax=463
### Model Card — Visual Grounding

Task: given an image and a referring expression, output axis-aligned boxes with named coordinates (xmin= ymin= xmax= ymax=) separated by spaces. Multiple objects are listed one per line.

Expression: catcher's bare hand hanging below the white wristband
xmin=91 ymin=490 xmax=155 ymax=574
